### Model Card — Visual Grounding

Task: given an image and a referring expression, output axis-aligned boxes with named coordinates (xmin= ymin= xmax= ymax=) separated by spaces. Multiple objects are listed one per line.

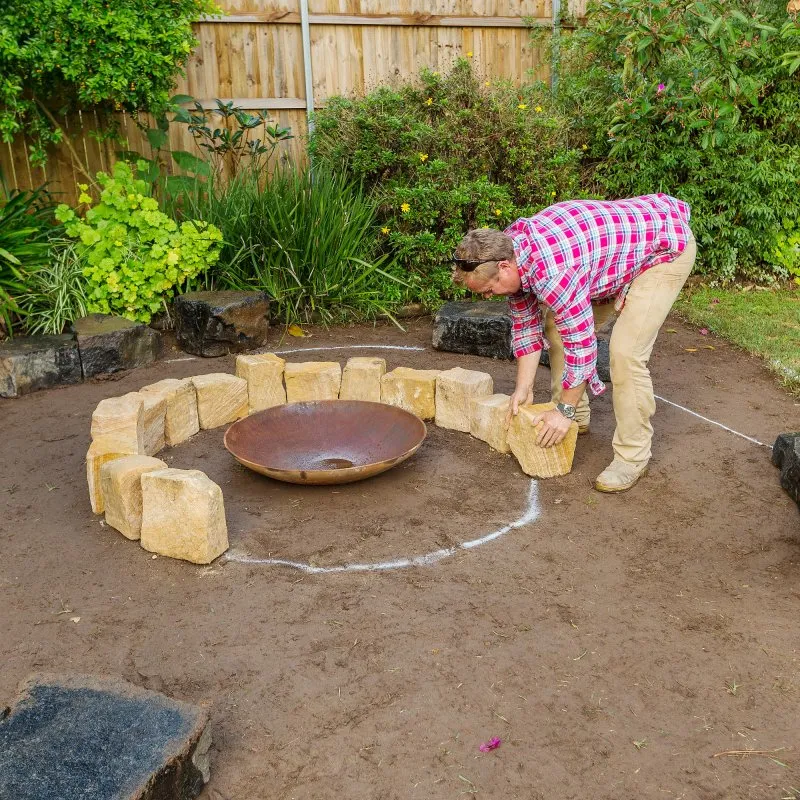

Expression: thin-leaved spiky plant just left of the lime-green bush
xmin=19 ymin=239 xmax=89 ymax=334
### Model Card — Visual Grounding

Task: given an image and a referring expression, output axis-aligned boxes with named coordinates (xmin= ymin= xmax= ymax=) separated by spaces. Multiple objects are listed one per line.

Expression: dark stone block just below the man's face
xmin=433 ymin=300 xmax=513 ymax=359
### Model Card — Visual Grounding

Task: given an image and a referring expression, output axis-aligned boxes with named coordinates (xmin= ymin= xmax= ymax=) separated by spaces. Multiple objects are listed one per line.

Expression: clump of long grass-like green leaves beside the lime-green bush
xmin=185 ymin=165 xmax=402 ymax=323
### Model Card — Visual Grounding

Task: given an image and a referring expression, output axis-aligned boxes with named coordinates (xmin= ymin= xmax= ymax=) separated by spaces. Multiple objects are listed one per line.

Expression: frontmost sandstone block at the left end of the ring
xmin=140 ymin=469 xmax=228 ymax=564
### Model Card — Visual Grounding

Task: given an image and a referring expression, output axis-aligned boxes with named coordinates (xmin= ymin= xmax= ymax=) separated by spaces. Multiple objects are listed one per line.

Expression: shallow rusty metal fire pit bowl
xmin=225 ymin=400 xmax=427 ymax=484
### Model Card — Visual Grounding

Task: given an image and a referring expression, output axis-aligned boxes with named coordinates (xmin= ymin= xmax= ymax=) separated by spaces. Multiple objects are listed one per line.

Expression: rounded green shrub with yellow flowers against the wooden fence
xmin=310 ymin=59 xmax=583 ymax=307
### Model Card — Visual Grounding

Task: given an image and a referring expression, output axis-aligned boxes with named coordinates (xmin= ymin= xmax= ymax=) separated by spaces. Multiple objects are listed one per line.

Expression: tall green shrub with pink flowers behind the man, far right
xmin=559 ymin=0 xmax=800 ymax=281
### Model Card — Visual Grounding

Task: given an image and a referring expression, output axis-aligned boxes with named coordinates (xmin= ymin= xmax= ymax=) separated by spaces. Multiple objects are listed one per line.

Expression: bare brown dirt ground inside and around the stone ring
xmin=0 ymin=320 xmax=800 ymax=800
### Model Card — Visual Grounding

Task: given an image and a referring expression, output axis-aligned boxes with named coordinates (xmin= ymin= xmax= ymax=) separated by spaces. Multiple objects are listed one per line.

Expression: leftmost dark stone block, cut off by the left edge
xmin=0 ymin=334 xmax=81 ymax=397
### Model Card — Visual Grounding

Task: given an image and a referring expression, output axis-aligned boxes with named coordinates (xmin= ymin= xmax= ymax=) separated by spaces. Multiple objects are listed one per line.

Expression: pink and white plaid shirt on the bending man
xmin=505 ymin=194 xmax=691 ymax=395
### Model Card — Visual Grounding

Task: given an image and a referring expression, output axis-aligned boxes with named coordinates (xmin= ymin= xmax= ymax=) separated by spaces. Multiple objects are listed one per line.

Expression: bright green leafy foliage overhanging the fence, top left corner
xmin=0 ymin=0 xmax=219 ymax=174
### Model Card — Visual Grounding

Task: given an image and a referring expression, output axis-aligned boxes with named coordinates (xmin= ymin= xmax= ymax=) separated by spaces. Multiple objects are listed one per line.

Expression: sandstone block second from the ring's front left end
xmin=100 ymin=456 xmax=167 ymax=539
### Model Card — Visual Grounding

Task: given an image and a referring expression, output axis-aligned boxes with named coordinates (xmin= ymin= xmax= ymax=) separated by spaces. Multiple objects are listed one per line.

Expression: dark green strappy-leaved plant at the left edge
xmin=0 ymin=189 xmax=56 ymax=334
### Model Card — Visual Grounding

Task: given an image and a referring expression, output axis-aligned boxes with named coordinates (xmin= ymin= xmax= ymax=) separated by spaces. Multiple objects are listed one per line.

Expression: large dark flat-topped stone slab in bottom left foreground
xmin=0 ymin=675 xmax=211 ymax=800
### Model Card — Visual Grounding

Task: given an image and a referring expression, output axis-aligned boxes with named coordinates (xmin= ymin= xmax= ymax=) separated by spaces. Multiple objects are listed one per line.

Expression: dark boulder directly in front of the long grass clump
xmin=174 ymin=292 xmax=269 ymax=358
